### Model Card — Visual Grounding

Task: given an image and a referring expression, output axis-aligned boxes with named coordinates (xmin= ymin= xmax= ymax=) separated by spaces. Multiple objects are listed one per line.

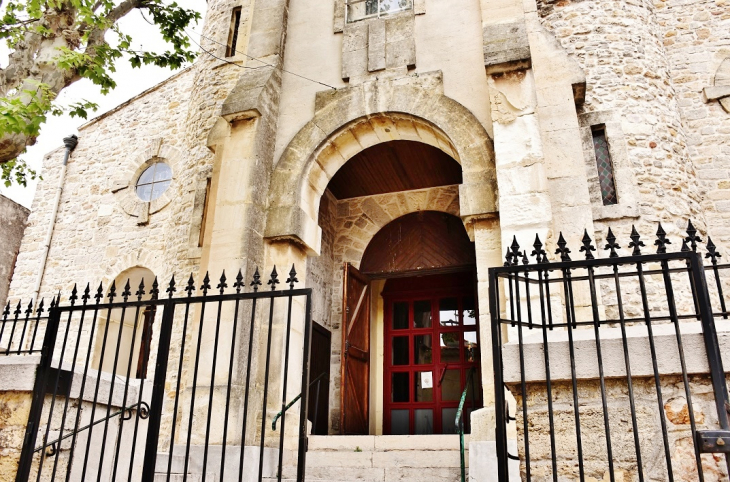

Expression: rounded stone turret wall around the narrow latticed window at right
xmin=537 ymin=0 xmax=700 ymax=243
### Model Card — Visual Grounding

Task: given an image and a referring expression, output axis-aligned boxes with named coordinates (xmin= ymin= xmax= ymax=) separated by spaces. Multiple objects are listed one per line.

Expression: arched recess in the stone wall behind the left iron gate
xmin=92 ymin=266 xmax=155 ymax=378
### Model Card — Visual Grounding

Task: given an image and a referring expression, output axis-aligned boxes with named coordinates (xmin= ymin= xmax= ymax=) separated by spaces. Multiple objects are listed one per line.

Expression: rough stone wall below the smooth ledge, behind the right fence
xmin=509 ymin=375 xmax=727 ymax=482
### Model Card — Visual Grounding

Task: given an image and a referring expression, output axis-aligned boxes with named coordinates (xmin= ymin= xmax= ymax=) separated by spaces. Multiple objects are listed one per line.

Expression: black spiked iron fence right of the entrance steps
xmin=490 ymin=223 xmax=730 ymax=482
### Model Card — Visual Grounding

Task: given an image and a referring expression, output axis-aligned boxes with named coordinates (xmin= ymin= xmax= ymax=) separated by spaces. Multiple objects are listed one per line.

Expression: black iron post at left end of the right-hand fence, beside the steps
xmin=489 ymin=268 xmax=509 ymax=480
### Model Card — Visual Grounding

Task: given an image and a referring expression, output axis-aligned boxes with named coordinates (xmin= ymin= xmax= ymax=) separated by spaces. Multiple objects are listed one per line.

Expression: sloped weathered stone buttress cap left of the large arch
xmin=221 ymin=67 xmax=275 ymax=122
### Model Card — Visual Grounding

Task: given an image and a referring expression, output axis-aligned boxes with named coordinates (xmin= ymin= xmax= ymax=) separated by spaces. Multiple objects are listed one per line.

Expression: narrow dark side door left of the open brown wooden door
xmin=307 ymin=323 xmax=332 ymax=435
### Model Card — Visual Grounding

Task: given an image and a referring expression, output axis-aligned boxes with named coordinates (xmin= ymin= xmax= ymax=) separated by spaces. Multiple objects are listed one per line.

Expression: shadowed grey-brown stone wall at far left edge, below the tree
xmin=0 ymin=195 xmax=30 ymax=306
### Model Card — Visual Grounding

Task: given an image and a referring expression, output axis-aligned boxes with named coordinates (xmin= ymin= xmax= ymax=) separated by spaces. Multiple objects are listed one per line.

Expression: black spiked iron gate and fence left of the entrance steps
xmin=5 ymin=267 xmax=311 ymax=482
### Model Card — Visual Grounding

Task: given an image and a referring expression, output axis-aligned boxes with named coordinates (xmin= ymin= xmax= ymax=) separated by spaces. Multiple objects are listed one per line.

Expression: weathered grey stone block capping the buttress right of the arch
xmin=482 ymin=20 xmax=531 ymax=74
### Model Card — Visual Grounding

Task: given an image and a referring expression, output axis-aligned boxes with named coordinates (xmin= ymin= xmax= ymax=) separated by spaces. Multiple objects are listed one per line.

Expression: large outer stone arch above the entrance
xmin=265 ymin=73 xmax=497 ymax=252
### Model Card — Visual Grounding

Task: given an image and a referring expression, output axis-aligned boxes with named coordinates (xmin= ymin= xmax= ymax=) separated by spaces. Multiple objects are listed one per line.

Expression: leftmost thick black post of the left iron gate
xmin=15 ymin=302 xmax=61 ymax=482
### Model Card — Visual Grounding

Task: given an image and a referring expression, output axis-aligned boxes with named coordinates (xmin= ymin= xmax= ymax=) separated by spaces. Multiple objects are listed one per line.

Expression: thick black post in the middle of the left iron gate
xmin=139 ymin=300 xmax=175 ymax=482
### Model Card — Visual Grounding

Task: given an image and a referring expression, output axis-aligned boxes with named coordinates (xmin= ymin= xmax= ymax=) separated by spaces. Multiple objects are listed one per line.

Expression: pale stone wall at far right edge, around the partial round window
xmin=655 ymin=0 xmax=730 ymax=246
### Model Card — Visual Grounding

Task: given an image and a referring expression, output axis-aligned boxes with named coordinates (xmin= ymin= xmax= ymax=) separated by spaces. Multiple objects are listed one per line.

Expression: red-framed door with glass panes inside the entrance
xmin=383 ymin=278 xmax=482 ymax=435
